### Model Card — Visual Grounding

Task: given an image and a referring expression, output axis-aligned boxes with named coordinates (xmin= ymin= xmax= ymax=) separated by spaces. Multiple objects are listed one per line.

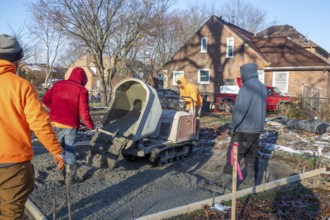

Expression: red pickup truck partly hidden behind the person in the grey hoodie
xmin=213 ymin=78 xmax=295 ymax=112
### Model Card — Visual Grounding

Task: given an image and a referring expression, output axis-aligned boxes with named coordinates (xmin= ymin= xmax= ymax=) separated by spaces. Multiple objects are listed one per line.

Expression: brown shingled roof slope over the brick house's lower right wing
xmin=251 ymin=36 xmax=330 ymax=67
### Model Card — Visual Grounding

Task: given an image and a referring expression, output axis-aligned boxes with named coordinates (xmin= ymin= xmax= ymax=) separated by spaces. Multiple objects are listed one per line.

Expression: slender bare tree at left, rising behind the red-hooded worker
xmin=29 ymin=3 xmax=65 ymax=89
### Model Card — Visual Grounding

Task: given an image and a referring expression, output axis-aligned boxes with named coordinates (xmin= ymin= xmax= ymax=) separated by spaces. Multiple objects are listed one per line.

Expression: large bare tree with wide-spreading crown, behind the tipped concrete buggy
xmin=38 ymin=0 xmax=173 ymax=104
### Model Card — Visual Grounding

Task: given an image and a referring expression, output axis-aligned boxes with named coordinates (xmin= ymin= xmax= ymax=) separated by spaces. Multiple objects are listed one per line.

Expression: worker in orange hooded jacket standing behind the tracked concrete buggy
xmin=176 ymin=76 xmax=203 ymax=139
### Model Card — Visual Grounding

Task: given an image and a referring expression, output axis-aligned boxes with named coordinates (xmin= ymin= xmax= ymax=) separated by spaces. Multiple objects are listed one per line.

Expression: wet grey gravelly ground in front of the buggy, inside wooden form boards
xmin=26 ymin=144 xmax=222 ymax=219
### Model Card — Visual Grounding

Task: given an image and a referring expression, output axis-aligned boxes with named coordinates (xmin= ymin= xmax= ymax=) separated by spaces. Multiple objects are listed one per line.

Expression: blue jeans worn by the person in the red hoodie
xmin=54 ymin=127 xmax=78 ymax=164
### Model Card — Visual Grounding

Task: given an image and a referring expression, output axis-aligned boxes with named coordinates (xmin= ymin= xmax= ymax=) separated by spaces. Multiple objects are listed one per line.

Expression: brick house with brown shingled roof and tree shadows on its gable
xmin=158 ymin=16 xmax=330 ymax=101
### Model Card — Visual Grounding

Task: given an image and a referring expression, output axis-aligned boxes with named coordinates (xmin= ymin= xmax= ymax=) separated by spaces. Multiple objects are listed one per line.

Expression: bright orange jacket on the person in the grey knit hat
xmin=0 ymin=59 xmax=62 ymax=164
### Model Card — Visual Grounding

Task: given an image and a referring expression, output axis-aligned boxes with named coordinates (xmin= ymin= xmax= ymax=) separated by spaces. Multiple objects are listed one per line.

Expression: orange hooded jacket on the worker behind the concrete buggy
xmin=177 ymin=76 xmax=203 ymax=110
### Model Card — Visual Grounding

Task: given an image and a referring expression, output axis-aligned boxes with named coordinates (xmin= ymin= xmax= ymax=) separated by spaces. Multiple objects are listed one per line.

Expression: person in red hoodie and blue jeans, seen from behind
xmin=43 ymin=67 xmax=94 ymax=186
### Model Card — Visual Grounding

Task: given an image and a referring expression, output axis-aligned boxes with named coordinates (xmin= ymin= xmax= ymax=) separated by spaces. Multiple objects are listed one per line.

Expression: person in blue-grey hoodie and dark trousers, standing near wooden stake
xmin=224 ymin=63 xmax=267 ymax=188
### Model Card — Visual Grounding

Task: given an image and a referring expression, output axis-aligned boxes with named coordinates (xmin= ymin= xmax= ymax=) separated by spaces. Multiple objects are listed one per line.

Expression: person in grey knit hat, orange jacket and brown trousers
xmin=0 ymin=35 xmax=64 ymax=220
